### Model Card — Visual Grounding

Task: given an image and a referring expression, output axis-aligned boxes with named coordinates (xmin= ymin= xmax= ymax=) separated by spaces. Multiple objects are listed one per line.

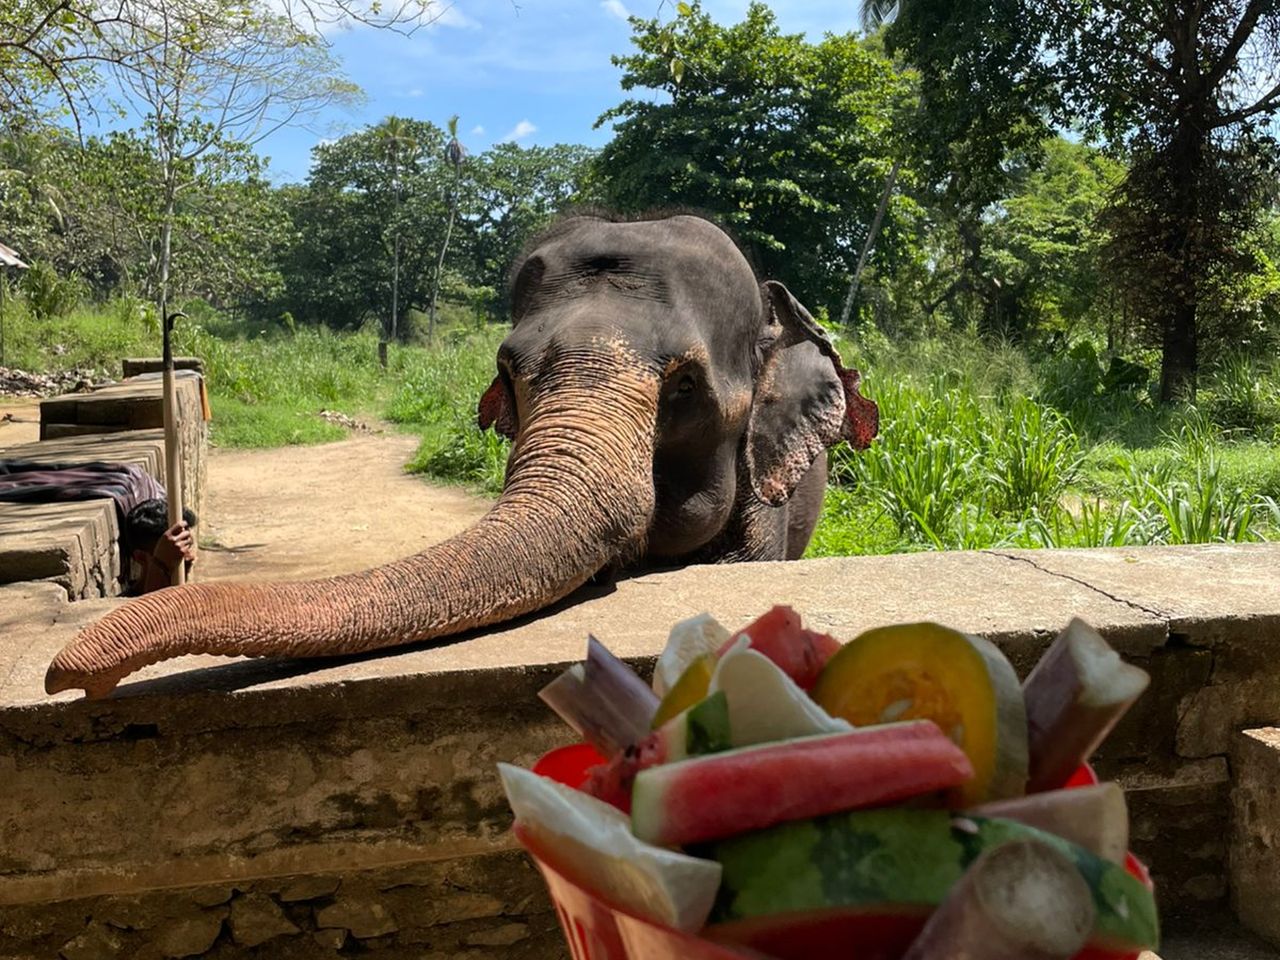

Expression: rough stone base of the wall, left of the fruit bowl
xmin=0 ymin=851 xmax=563 ymax=960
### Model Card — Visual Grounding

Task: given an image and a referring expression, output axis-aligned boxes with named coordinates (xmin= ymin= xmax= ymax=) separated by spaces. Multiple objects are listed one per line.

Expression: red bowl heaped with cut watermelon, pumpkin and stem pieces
xmin=502 ymin=607 xmax=1158 ymax=960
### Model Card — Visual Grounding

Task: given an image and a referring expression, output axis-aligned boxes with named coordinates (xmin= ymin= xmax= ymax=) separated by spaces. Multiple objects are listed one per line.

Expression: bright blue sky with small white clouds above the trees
xmin=259 ymin=0 xmax=858 ymax=182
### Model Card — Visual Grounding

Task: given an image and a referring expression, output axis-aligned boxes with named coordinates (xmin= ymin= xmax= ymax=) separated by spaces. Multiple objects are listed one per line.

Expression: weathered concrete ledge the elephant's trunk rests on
xmin=0 ymin=545 xmax=1280 ymax=957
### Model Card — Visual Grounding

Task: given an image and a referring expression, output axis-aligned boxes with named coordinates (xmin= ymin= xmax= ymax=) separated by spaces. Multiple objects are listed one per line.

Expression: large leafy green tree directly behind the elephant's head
xmin=596 ymin=3 xmax=914 ymax=310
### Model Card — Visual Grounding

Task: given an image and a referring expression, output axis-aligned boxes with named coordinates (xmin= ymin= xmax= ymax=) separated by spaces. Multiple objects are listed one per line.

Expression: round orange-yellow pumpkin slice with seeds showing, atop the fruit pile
xmin=813 ymin=623 xmax=1027 ymax=806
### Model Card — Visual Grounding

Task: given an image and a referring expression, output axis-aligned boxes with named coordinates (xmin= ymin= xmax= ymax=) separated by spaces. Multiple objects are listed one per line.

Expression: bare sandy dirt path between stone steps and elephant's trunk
xmin=198 ymin=431 xmax=489 ymax=580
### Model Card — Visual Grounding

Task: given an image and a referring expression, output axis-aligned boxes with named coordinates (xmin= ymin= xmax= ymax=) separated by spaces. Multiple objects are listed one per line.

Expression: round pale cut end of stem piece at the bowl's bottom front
xmin=902 ymin=840 xmax=1096 ymax=960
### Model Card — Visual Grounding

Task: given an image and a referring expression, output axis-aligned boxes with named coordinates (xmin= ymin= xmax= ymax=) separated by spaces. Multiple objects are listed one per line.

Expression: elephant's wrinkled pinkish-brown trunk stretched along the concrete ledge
xmin=45 ymin=355 xmax=658 ymax=698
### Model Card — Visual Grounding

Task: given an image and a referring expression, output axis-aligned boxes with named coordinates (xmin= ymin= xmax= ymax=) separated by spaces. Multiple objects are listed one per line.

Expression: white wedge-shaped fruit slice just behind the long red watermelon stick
xmin=710 ymin=641 xmax=852 ymax=746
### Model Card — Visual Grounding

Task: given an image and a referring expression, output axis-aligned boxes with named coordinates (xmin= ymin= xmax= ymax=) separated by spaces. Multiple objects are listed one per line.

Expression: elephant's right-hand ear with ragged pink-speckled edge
xmin=746 ymin=280 xmax=879 ymax=507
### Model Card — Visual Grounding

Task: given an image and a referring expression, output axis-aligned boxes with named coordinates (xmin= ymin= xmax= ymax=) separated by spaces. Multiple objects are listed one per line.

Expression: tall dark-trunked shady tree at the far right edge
xmin=888 ymin=0 xmax=1280 ymax=401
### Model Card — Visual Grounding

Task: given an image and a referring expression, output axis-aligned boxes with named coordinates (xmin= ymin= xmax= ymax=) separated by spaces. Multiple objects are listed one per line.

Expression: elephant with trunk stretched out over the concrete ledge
xmin=45 ymin=212 xmax=878 ymax=698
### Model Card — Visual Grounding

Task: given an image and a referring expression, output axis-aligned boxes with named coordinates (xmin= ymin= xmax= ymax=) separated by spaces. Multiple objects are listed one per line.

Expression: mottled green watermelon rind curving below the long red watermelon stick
xmin=706 ymin=809 xmax=1160 ymax=950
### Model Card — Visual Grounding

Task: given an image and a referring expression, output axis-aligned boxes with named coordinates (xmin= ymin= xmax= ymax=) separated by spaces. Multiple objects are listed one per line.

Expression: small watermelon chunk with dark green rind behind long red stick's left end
xmin=582 ymin=694 xmax=733 ymax=813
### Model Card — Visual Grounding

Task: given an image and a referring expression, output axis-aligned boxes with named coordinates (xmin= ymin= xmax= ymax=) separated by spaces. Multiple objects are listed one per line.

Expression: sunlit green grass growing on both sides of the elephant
xmin=5 ymin=301 xmax=1280 ymax=556
